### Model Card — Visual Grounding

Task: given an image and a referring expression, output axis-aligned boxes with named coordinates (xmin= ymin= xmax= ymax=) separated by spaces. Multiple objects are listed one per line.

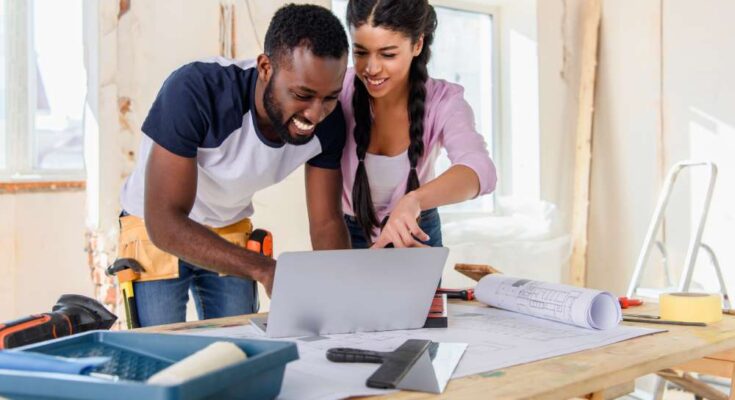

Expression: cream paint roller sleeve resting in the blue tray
xmin=148 ymin=342 xmax=247 ymax=385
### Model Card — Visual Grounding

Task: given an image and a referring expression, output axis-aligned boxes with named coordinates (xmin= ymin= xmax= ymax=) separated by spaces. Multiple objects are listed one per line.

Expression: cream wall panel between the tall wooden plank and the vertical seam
xmin=587 ymin=0 xmax=661 ymax=293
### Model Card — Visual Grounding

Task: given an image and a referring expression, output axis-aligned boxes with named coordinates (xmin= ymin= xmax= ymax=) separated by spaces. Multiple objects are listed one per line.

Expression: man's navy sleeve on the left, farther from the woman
xmin=142 ymin=63 xmax=212 ymax=158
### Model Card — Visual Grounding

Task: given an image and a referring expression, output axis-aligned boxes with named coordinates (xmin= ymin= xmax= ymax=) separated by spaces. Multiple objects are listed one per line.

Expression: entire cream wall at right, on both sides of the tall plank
xmin=538 ymin=0 xmax=735 ymax=293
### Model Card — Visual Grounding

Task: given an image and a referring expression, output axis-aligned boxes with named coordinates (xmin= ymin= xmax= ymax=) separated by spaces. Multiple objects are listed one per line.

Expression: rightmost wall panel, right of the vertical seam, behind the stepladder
xmin=662 ymin=0 xmax=735 ymax=293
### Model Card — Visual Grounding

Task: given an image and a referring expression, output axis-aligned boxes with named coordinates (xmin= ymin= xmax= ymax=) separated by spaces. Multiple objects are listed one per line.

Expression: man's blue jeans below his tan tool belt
xmin=133 ymin=260 xmax=259 ymax=327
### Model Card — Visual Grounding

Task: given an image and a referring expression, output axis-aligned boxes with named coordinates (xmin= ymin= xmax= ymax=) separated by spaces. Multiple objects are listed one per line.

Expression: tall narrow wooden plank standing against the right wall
xmin=569 ymin=0 xmax=602 ymax=286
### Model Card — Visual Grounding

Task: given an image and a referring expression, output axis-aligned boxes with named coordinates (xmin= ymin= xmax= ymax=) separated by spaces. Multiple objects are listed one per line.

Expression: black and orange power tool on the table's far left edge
xmin=0 ymin=294 xmax=117 ymax=350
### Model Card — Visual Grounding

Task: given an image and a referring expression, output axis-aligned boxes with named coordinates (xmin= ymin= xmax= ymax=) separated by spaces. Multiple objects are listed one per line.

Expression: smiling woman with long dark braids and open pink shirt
xmin=340 ymin=0 xmax=496 ymax=248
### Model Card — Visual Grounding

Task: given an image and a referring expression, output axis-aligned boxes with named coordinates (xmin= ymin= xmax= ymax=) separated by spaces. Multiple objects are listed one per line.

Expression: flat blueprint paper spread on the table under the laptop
xmin=182 ymin=304 xmax=662 ymax=400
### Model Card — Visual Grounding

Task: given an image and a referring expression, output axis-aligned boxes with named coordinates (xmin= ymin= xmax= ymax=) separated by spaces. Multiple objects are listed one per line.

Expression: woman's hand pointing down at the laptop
xmin=371 ymin=192 xmax=429 ymax=249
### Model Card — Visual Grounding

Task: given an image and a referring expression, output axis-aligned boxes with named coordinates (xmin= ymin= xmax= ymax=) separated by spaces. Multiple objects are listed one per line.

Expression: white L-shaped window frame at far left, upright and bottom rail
xmin=0 ymin=0 xmax=87 ymax=187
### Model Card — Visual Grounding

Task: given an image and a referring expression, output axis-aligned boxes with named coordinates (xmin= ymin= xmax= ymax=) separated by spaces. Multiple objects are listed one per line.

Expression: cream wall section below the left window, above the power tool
xmin=0 ymin=191 xmax=92 ymax=321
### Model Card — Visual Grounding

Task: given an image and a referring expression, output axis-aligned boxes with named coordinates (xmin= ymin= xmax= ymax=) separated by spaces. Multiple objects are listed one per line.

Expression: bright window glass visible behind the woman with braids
xmin=332 ymin=0 xmax=498 ymax=213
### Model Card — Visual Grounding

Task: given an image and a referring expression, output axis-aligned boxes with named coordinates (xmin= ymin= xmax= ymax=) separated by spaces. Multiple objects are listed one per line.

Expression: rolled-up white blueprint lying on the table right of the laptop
xmin=475 ymin=274 xmax=623 ymax=329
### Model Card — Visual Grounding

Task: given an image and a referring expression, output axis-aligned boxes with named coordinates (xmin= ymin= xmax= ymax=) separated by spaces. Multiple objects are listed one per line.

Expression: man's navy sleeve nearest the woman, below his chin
xmin=307 ymin=103 xmax=347 ymax=169
